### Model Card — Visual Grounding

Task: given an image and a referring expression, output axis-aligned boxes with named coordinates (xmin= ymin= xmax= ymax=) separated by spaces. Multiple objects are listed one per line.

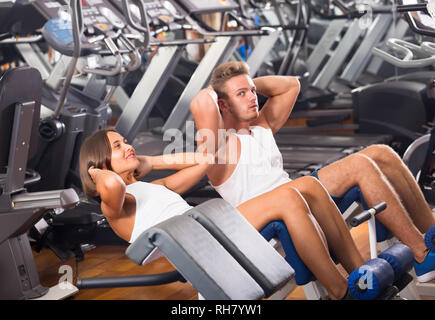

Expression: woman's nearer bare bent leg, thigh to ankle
xmin=237 ymin=186 xmax=347 ymax=299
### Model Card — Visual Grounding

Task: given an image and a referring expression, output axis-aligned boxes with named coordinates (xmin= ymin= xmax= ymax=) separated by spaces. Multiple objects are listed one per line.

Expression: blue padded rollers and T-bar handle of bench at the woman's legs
xmin=261 ymin=203 xmax=413 ymax=300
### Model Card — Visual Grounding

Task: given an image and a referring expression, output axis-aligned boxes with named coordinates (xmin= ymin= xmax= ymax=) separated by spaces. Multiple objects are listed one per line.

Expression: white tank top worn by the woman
xmin=126 ymin=181 xmax=192 ymax=243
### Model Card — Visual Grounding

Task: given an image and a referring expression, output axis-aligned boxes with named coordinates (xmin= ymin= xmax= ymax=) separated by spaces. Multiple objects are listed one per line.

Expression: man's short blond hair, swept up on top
xmin=210 ymin=61 xmax=249 ymax=99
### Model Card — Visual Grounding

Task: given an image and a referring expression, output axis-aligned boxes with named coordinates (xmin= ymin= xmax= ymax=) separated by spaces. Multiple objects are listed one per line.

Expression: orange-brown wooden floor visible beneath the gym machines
xmin=34 ymin=223 xmax=435 ymax=300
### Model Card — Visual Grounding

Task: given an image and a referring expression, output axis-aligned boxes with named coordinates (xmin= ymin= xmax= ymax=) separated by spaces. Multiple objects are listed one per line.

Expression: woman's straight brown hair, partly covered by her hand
xmin=80 ymin=128 xmax=117 ymax=197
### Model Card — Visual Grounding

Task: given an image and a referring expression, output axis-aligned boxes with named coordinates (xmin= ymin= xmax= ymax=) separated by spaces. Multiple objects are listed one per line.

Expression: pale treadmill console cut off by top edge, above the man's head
xmin=176 ymin=0 xmax=240 ymax=14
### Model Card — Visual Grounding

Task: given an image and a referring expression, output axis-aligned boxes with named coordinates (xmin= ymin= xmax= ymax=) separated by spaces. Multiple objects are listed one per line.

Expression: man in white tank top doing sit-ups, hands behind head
xmin=190 ymin=62 xmax=435 ymax=282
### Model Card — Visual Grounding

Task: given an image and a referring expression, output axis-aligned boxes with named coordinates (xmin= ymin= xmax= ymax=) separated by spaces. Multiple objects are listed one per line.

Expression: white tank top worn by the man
xmin=212 ymin=126 xmax=291 ymax=207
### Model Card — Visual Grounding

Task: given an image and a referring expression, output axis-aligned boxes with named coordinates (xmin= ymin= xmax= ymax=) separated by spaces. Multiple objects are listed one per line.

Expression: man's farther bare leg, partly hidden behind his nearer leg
xmin=360 ymin=145 xmax=435 ymax=233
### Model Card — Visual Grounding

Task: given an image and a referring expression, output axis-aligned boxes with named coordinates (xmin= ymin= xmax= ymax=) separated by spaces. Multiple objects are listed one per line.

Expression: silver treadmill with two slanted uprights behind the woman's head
xmin=112 ymin=0 xmax=279 ymax=175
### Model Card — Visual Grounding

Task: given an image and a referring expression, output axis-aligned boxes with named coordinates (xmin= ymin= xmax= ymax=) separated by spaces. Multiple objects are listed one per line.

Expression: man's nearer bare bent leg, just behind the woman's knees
xmin=318 ymin=153 xmax=427 ymax=262
